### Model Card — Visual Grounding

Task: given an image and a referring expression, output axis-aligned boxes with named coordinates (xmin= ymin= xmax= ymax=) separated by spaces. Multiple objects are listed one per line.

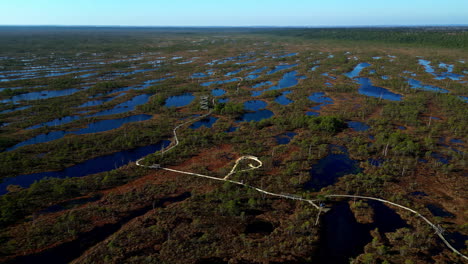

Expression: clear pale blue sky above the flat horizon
xmin=0 ymin=0 xmax=468 ymax=26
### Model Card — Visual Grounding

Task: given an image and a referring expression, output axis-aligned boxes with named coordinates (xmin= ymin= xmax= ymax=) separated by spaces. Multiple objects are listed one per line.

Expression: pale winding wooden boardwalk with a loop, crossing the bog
xmin=136 ymin=110 xmax=468 ymax=260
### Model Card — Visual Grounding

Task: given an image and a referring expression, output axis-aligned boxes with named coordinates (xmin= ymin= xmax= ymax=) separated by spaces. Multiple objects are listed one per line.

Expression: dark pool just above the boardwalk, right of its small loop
xmin=304 ymin=146 xmax=361 ymax=191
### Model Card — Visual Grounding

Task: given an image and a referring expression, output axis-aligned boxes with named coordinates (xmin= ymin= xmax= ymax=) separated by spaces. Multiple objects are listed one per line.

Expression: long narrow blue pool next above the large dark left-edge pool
xmin=6 ymin=115 xmax=152 ymax=151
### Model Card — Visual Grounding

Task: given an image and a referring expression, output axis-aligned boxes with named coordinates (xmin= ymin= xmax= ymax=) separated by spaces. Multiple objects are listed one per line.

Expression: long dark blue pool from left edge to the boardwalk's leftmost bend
xmin=0 ymin=140 xmax=170 ymax=195
